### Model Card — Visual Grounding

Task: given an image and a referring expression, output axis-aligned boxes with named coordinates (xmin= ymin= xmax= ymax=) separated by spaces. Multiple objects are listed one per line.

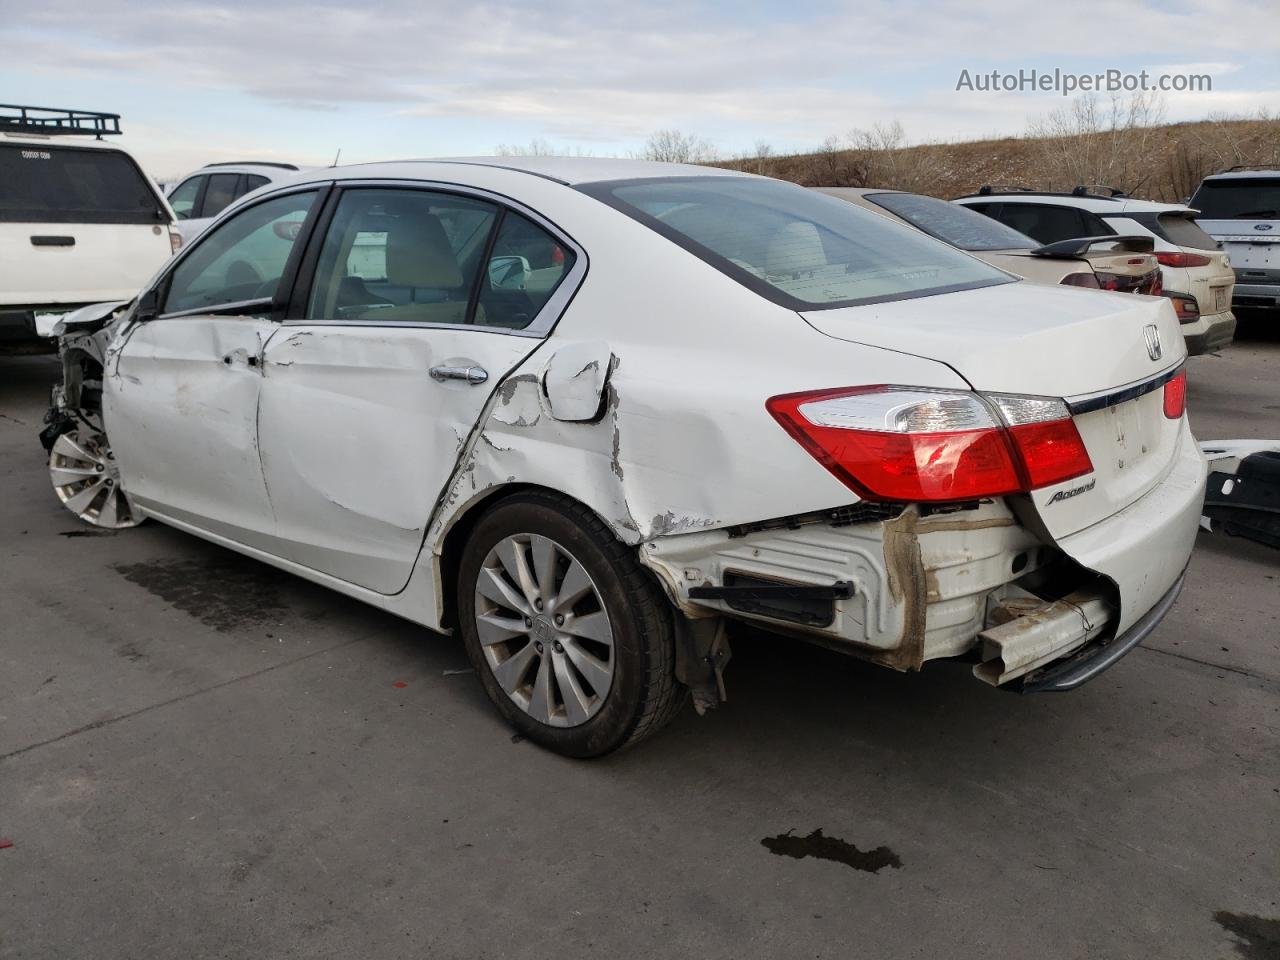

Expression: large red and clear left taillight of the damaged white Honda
xmin=767 ymin=387 xmax=1093 ymax=503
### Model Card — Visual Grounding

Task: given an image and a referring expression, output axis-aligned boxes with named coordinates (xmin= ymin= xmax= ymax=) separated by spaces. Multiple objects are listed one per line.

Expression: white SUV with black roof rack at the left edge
xmin=0 ymin=105 xmax=182 ymax=351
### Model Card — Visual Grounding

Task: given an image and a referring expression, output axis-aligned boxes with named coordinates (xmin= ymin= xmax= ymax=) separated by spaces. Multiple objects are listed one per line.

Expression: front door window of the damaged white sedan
xmin=161 ymin=191 xmax=316 ymax=314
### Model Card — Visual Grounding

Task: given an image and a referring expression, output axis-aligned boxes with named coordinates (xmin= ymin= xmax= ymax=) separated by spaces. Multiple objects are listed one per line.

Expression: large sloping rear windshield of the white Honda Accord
xmin=581 ymin=177 xmax=1014 ymax=310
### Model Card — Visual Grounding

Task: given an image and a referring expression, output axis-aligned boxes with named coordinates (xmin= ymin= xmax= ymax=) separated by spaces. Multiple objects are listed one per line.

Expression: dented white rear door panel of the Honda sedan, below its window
xmin=259 ymin=324 xmax=529 ymax=594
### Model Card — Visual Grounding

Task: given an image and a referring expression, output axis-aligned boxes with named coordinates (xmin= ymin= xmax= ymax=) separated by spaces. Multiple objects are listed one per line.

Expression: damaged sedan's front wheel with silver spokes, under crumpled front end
xmin=49 ymin=426 xmax=142 ymax=530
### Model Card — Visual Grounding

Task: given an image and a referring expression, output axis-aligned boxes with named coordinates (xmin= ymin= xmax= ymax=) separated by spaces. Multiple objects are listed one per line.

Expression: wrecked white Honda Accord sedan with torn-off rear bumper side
xmin=44 ymin=157 xmax=1204 ymax=756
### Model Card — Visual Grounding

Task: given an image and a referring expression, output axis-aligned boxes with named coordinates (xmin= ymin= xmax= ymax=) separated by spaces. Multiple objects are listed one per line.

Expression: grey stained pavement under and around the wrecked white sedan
xmin=0 ymin=320 xmax=1280 ymax=960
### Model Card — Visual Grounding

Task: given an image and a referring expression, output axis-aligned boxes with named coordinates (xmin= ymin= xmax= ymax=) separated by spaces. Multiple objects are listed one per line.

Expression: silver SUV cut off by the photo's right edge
xmin=1190 ymin=166 xmax=1280 ymax=308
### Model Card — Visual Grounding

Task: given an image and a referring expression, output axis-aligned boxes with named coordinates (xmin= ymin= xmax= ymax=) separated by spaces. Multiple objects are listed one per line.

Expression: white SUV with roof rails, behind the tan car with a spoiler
xmin=955 ymin=187 xmax=1235 ymax=353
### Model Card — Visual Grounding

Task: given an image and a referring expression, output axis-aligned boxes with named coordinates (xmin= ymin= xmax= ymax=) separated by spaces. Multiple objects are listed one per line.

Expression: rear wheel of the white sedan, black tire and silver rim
xmin=457 ymin=493 xmax=687 ymax=758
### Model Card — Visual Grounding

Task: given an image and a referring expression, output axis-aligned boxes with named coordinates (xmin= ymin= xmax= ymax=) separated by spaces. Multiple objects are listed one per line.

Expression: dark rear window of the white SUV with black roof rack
xmin=0 ymin=143 xmax=169 ymax=224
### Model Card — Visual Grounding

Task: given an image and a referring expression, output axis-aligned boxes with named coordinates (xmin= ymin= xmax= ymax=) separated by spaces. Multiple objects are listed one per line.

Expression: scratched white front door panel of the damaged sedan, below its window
xmin=104 ymin=315 xmax=276 ymax=552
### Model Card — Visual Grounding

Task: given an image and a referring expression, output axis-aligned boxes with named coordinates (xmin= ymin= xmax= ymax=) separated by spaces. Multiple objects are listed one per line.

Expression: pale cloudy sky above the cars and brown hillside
xmin=0 ymin=0 xmax=1280 ymax=178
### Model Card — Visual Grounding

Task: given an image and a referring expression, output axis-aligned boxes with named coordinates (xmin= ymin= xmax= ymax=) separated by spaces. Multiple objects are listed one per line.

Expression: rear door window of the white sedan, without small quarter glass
xmin=306 ymin=188 xmax=498 ymax=324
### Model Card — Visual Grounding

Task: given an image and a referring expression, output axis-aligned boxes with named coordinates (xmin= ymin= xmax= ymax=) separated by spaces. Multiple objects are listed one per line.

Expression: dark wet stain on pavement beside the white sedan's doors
xmin=115 ymin=557 xmax=287 ymax=632
